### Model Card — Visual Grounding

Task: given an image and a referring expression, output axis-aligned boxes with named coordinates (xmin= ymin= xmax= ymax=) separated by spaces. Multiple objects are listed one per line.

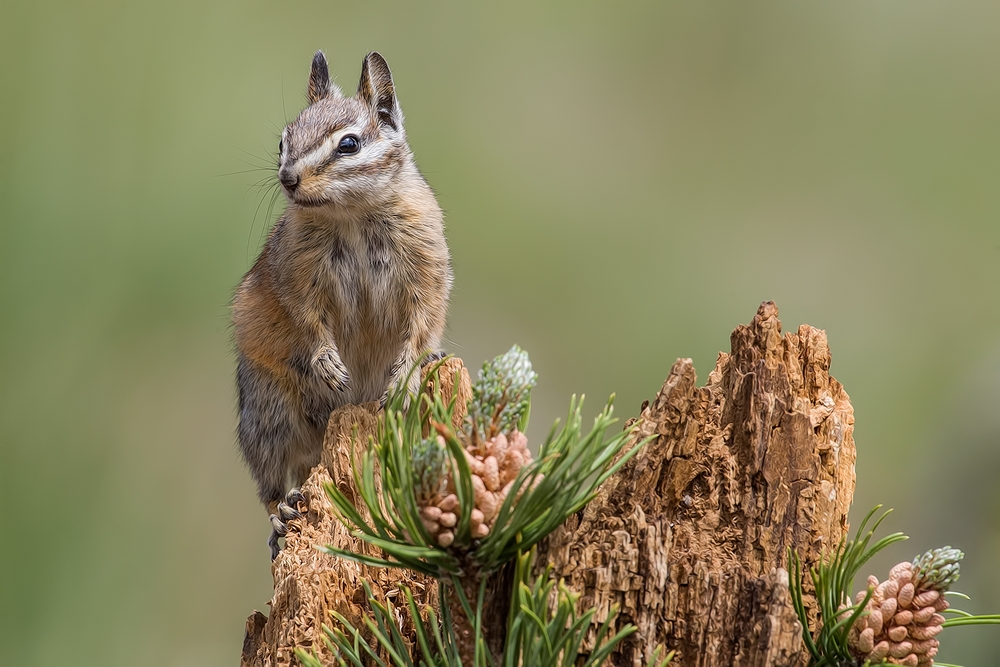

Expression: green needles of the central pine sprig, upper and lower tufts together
xmin=304 ymin=346 xmax=673 ymax=667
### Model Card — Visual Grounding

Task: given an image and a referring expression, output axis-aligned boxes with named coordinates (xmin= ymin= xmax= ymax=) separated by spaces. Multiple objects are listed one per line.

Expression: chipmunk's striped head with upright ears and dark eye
xmin=278 ymin=51 xmax=412 ymax=207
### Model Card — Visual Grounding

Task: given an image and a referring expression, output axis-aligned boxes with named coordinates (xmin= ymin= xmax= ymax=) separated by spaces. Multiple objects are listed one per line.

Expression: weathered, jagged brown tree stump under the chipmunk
xmin=241 ymin=302 xmax=855 ymax=667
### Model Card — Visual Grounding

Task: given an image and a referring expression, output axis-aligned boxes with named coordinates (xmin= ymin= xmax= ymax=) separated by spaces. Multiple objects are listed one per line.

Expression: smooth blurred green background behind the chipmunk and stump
xmin=0 ymin=0 xmax=1000 ymax=667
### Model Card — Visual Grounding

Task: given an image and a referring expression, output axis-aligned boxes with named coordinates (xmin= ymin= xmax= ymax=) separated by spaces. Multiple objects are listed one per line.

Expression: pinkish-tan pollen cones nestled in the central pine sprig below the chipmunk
xmin=418 ymin=429 xmax=531 ymax=547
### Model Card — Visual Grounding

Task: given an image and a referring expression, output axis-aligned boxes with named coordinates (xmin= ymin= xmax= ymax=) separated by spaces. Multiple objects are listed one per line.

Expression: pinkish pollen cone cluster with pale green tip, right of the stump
xmin=849 ymin=547 xmax=963 ymax=667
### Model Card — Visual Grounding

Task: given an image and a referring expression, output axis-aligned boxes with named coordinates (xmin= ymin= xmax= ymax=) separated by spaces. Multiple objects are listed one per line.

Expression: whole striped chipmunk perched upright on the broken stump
xmin=232 ymin=51 xmax=452 ymax=560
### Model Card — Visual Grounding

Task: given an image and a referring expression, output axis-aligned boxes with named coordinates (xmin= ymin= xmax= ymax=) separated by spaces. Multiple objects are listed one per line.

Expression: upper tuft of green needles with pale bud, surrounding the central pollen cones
xmin=323 ymin=346 xmax=645 ymax=578
